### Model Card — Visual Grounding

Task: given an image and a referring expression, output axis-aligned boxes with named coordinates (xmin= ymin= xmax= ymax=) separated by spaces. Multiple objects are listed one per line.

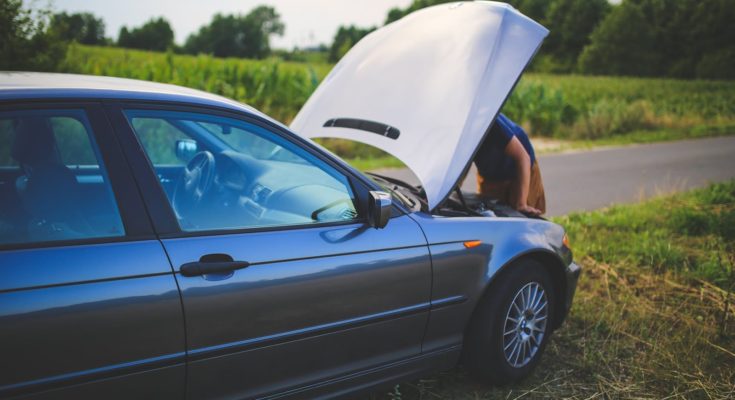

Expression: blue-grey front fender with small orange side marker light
xmin=411 ymin=213 xmax=571 ymax=351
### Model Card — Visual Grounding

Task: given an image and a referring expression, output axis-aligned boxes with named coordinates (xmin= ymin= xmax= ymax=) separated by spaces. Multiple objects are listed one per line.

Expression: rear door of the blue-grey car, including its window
xmin=0 ymin=102 xmax=185 ymax=398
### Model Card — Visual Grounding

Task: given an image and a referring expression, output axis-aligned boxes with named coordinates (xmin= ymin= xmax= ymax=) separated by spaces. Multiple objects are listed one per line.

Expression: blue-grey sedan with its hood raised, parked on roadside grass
xmin=0 ymin=2 xmax=580 ymax=399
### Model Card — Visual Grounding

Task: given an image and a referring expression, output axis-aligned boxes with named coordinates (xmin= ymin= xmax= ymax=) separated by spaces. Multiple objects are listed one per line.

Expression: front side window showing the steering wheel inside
xmin=126 ymin=110 xmax=358 ymax=231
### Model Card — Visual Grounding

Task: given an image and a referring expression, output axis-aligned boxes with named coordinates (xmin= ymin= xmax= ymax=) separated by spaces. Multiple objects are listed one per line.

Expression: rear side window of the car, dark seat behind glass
xmin=0 ymin=110 xmax=125 ymax=245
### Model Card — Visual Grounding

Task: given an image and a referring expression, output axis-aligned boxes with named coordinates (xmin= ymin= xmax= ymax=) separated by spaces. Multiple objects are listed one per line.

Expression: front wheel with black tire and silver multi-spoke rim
xmin=463 ymin=259 xmax=556 ymax=385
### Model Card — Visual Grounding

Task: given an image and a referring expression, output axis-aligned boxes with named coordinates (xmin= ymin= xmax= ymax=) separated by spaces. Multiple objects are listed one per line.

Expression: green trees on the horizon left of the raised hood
xmin=0 ymin=0 xmax=285 ymax=70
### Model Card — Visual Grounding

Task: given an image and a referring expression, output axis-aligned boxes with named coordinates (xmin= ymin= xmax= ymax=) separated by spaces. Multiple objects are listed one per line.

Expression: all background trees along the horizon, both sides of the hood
xmin=0 ymin=0 xmax=735 ymax=79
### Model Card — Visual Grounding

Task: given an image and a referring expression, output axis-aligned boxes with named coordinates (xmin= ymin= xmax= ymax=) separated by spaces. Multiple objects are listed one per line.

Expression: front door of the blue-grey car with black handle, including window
xmin=110 ymin=105 xmax=431 ymax=399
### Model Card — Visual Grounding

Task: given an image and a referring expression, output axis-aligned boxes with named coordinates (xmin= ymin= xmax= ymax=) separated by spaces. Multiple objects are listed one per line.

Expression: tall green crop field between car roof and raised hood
xmin=62 ymin=45 xmax=331 ymax=122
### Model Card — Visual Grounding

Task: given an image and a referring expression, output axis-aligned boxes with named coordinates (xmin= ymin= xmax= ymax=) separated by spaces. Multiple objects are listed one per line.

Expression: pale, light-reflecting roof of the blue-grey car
xmin=0 ymin=72 xmax=283 ymax=126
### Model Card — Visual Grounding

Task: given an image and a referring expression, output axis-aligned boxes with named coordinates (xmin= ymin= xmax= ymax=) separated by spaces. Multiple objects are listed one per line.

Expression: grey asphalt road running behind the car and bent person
xmin=381 ymin=136 xmax=735 ymax=216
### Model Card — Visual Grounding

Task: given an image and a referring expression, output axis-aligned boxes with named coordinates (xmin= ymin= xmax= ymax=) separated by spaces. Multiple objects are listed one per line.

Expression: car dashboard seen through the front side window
xmin=180 ymin=150 xmax=358 ymax=230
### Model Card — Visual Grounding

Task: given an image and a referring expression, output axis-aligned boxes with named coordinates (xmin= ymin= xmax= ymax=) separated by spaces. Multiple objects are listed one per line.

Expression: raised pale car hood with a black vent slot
xmin=291 ymin=1 xmax=549 ymax=210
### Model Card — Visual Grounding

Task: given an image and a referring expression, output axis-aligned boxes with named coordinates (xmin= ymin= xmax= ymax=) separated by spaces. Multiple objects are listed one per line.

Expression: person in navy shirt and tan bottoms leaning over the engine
xmin=474 ymin=114 xmax=546 ymax=215
